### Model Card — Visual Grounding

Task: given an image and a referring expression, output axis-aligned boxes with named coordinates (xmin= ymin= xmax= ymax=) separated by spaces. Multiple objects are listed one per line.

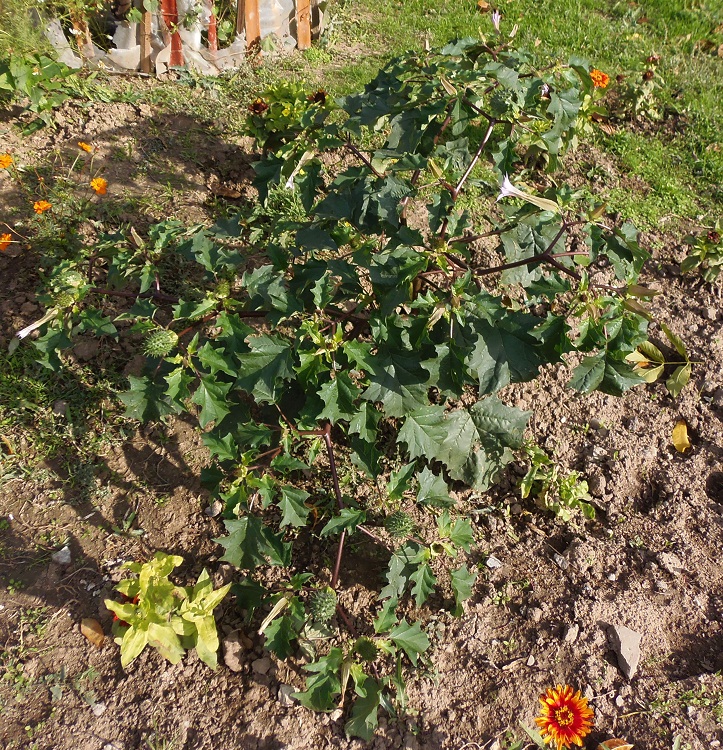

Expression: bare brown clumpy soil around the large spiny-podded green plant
xmin=0 ymin=83 xmax=723 ymax=750
